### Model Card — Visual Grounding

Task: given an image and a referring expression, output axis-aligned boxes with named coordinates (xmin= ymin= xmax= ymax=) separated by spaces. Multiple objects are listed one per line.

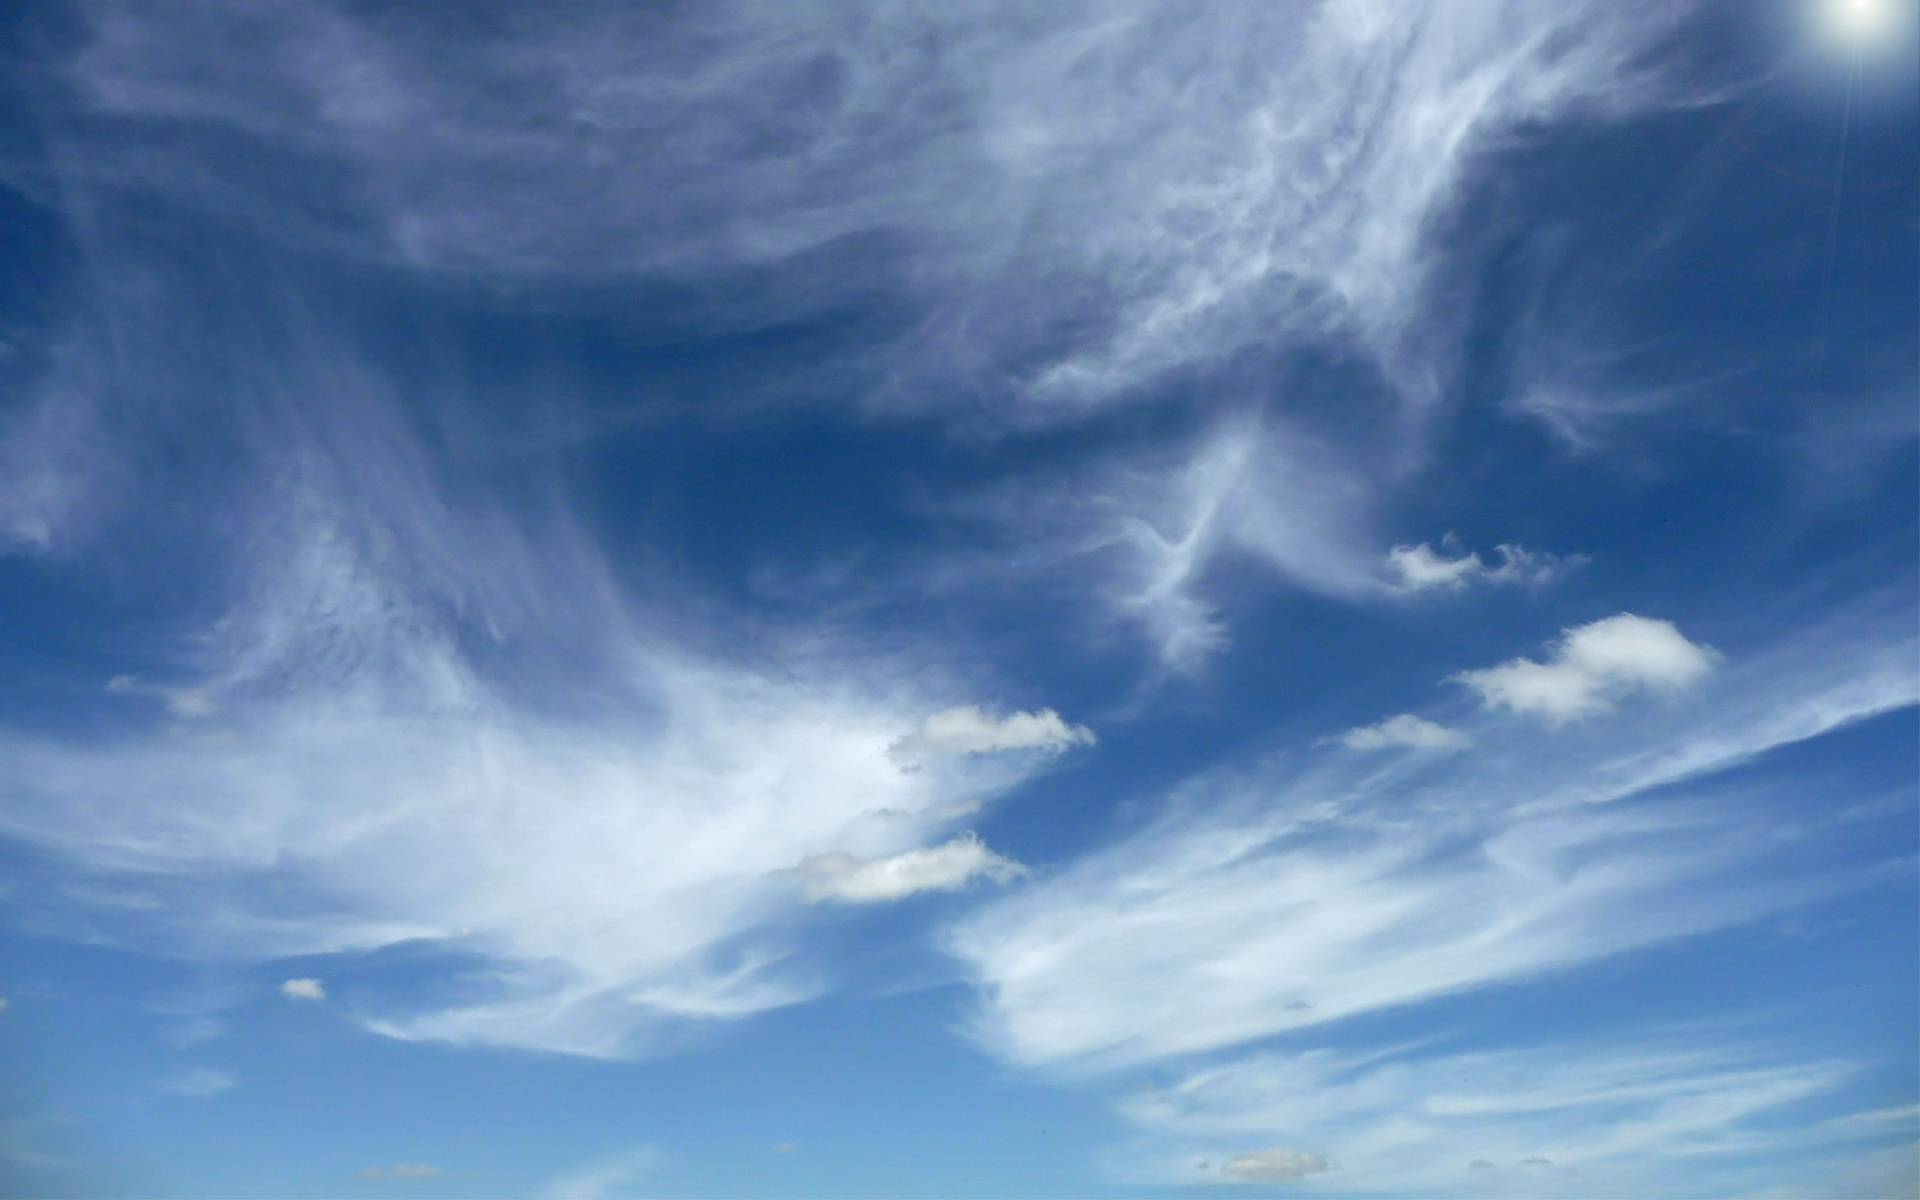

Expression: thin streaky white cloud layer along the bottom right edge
xmin=1116 ymin=1027 xmax=1878 ymax=1196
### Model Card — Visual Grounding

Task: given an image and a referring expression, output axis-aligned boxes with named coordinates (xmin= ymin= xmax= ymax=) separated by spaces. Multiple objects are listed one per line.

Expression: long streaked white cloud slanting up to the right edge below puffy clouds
xmin=947 ymin=601 xmax=1920 ymax=1069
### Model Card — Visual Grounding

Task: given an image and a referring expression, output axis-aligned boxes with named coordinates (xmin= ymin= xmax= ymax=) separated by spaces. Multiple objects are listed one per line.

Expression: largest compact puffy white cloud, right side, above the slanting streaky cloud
xmin=1453 ymin=612 xmax=1720 ymax=724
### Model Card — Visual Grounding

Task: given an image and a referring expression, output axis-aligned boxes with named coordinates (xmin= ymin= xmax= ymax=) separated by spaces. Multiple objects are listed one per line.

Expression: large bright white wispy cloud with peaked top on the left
xmin=0 ymin=470 xmax=1083 ymax=1056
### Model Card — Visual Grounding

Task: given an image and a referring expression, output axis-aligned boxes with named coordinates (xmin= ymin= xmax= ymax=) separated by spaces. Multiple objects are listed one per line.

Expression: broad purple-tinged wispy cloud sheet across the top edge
xmin=56 ymin=2 xmax=1681 ymax=420
